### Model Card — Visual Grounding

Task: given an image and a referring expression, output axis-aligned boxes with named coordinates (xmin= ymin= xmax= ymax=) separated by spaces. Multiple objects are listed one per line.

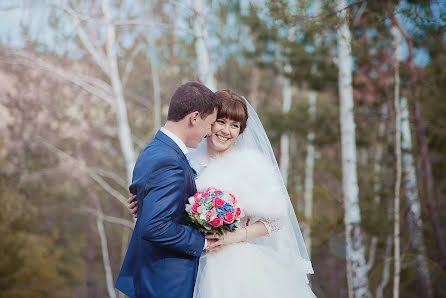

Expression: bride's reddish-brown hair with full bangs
xmin=215 ymin=89 xmax=248 ymax=133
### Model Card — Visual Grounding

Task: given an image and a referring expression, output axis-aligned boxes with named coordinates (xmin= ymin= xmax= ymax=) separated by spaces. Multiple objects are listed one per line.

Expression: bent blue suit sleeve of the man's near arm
xmin=138 ymin=162 xmax=205 ymax=256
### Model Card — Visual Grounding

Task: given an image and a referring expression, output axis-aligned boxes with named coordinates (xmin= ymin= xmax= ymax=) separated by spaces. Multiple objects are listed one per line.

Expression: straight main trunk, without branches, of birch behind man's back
xmin=102 ymin=0 xmax=136 ymax=184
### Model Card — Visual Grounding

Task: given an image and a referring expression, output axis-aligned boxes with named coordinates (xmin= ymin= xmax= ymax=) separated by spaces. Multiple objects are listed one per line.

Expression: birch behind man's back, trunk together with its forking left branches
xmin=13 ymin=0 xmax=136 ymax=183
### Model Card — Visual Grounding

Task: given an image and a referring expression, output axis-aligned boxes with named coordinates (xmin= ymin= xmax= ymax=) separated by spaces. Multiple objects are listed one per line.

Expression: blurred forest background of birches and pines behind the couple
xmin=0 ymin=0 xmax=446 ymax=298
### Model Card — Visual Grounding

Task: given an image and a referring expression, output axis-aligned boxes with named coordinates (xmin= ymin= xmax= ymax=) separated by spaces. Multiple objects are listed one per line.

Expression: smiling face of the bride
xmin=207 ymin=118 xmax=240 ymax=155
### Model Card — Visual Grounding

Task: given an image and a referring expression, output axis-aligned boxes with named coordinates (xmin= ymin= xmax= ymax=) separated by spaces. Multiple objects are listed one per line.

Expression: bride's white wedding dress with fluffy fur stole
xmin=191 ymin=147 xmax=316 ymax=298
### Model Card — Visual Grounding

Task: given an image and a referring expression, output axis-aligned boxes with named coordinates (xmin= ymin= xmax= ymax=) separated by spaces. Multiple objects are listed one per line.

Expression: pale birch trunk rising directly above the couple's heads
xmin=193 ymin=0 xmax=217 ymax=91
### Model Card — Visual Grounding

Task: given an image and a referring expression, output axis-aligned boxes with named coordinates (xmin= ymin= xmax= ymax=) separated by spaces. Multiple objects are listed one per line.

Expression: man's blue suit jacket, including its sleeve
xmin=115 ymin=131 xmax=204 ymax=298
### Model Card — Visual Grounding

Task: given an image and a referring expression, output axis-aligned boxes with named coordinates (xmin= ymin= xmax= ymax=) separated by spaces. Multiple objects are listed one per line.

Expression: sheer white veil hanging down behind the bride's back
xmin=233 ymin=96 xmax=314 ymax=274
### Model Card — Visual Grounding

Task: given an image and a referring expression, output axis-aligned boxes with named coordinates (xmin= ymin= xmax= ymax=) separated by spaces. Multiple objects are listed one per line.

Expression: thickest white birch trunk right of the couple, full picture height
xmin=337 ymin=0 xmax=370 ymax=298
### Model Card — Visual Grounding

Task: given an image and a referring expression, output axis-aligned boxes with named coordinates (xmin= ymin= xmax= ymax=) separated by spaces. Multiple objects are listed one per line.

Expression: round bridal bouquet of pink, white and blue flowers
xmin=186 ymin=187 xmax=244 ymax=236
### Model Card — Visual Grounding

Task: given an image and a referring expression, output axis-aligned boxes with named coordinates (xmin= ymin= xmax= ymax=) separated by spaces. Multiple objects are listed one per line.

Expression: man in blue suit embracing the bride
xmin=115 ymin=82 xmax=221 ymax=298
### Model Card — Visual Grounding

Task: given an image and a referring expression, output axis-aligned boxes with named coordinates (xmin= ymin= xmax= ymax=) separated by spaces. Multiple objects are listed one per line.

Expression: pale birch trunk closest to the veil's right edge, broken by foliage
xmin=280 ymin=78 xmax=291 ymax=186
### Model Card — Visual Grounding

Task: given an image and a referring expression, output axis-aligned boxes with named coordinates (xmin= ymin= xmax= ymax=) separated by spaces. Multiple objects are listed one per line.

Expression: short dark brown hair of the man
xmin=167 ymin=82 xmax=221 ymax=122
